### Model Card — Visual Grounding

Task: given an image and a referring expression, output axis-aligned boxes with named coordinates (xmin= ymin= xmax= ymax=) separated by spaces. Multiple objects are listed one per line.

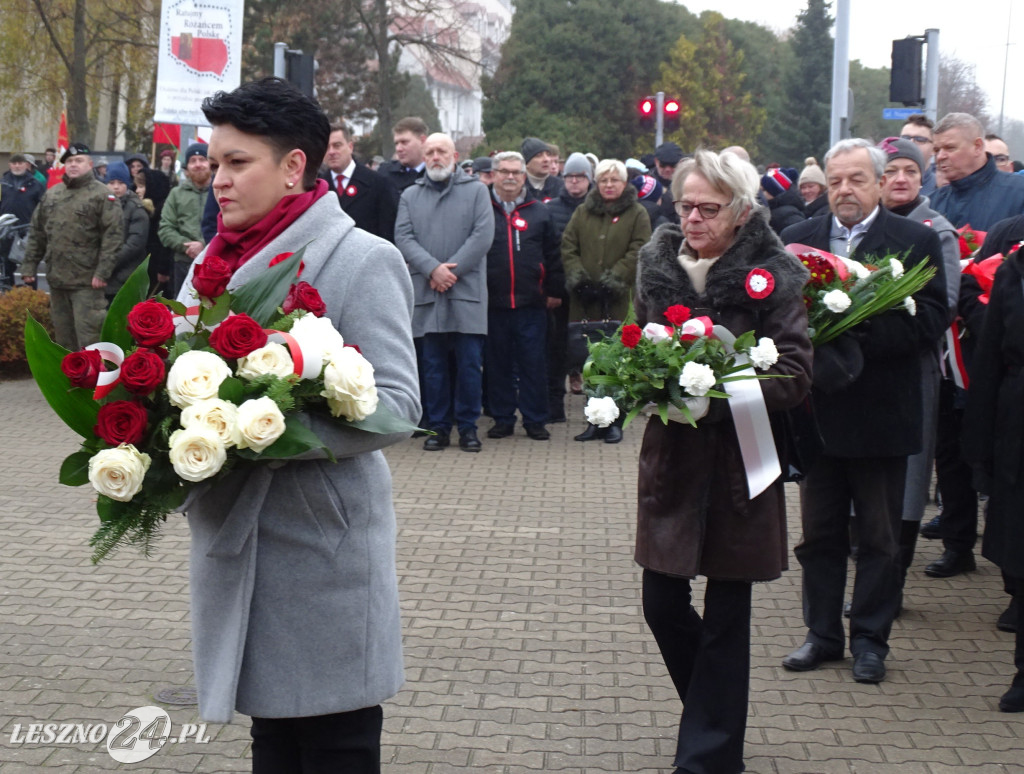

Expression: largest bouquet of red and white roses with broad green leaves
xmin=26 ymin=251 xmax=415 ymax=562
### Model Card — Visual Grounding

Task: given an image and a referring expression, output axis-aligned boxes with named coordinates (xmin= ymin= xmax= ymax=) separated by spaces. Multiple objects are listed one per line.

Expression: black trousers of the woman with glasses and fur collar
xmin=643 ymin=570 xmax=751 ymax=774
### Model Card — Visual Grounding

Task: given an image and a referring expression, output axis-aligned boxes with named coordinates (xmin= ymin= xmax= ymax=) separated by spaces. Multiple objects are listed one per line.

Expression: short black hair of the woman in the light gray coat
xmin=203 ymin=78 xmax=331 ymax=190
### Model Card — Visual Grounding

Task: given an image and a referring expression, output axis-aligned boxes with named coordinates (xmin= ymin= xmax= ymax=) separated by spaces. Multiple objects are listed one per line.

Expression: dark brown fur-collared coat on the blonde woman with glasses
xmin=634 ymin=211 xmax=812 ymax=581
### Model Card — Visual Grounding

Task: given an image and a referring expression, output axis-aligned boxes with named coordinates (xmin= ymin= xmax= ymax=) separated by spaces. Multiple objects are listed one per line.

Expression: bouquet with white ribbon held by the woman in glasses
xmin=583 ymin=305 xmax=778 ymax=427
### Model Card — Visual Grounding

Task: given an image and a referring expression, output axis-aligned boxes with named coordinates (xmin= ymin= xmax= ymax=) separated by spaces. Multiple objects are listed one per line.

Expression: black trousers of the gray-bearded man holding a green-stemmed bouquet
xmin=794 ymin=456 xmax=906 ymax=658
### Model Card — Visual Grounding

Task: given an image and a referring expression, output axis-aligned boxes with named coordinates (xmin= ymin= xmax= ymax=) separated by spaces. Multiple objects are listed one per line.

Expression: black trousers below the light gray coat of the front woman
xmin=250 ymin=705 xmax=384 ymax=774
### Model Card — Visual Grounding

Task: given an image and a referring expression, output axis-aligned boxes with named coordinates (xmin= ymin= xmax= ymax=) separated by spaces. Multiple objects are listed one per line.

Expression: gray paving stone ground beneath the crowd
xmin=0 ymin=372 xmax=1024 ymax=774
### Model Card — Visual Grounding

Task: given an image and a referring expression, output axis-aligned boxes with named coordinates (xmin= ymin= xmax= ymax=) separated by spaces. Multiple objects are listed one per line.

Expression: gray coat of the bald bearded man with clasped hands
xmin=394 ymin=167 xmax=495 ymax=338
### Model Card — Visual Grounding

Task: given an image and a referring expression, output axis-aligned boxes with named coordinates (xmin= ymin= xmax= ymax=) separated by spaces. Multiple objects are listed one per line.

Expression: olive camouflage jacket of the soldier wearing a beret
xmin=22 ymin=174 xmax=124 ymax=288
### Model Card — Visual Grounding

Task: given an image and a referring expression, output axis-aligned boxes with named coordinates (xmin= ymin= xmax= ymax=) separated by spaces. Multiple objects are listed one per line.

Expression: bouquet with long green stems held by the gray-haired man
xmin=785 ymin=244 xmax=935 ymax=346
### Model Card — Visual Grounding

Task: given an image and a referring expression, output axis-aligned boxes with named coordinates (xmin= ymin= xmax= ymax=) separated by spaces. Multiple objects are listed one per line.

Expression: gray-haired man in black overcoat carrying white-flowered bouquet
xmin=782 ymin=139 xmax=947 ymax=683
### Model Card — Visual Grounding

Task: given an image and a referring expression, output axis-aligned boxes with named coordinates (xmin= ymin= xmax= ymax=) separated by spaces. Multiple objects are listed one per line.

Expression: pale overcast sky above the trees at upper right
xmin=678 ymin=0 xmax=1024 ymax=123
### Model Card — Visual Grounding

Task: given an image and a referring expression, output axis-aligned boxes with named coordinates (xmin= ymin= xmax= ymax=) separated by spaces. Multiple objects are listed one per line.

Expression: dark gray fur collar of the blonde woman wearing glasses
xmin=637 ymin=210 xmax=809 ymax=313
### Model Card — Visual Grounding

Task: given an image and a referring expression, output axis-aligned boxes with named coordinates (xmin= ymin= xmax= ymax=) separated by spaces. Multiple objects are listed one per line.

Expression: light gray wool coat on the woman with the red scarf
xmin=179 ymin=193 xmax=419 ymax=723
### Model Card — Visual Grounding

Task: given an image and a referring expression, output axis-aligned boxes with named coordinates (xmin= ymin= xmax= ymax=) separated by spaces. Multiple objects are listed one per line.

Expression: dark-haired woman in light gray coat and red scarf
xmin=179 ymin=79 xmax=420 ymax=774
